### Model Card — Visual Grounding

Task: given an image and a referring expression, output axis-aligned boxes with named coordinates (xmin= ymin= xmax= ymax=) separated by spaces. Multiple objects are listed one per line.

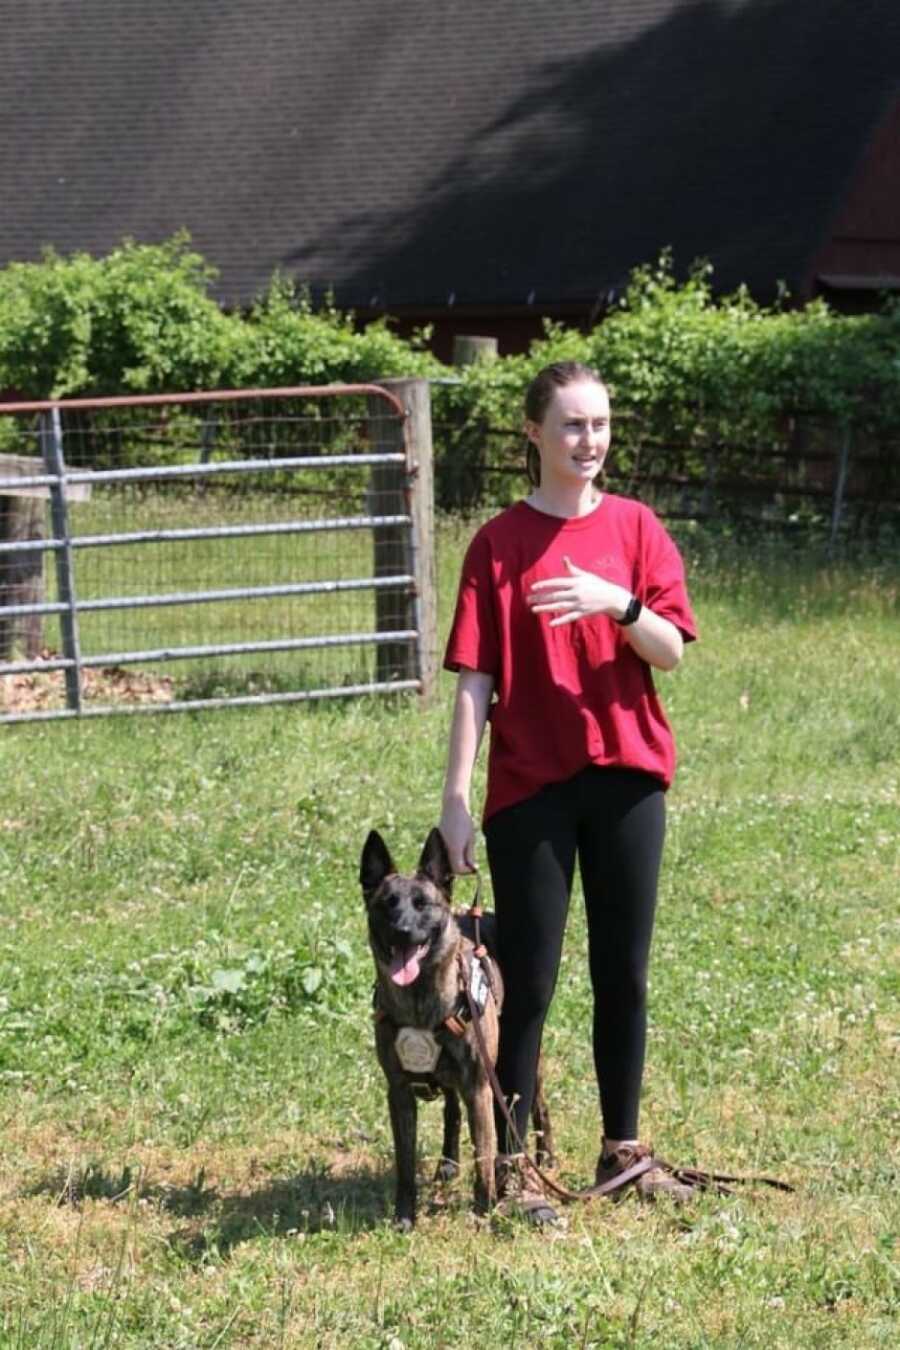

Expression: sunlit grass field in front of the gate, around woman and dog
xmin=0 ymin=528 xmax=900 ymax=1350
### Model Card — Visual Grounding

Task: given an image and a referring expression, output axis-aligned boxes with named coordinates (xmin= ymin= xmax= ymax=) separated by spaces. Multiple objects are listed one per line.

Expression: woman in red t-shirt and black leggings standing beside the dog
xmin=440 ymin=362 xmax=696 ymax=1222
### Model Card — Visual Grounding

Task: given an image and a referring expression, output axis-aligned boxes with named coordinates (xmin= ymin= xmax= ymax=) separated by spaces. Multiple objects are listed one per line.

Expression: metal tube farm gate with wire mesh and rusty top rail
xmin=0 ymin=381 xmax=434 ymax=722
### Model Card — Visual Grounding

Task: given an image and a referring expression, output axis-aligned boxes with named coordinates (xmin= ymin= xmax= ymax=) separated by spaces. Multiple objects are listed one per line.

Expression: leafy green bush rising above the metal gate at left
xmin=0 ymin=235 xmax=443 ymax=398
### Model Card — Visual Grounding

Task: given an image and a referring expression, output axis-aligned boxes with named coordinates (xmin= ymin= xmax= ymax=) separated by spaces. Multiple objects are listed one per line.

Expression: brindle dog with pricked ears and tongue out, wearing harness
xmin=359 ymin=829 xmax=552 ymax=1229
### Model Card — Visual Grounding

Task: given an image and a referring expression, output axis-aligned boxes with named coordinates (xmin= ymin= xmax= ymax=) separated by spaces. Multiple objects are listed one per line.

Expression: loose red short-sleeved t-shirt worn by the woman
xmin=444 ymin=493 xmax=696 ymax=819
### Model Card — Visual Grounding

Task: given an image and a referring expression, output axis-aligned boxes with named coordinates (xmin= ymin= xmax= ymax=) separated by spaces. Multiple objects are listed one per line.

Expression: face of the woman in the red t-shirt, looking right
xmin=525 ymin=379 xmax=610 ymax=486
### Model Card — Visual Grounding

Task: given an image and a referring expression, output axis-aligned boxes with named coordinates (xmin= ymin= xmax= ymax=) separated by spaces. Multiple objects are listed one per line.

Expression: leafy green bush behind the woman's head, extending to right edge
xmin=436 ymin=254 xmax=900 ymax=504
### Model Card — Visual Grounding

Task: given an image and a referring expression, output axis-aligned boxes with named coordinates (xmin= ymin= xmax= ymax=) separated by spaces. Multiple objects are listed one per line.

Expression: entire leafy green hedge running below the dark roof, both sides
xmin=0 ymin=235 xmax=900 ymax=506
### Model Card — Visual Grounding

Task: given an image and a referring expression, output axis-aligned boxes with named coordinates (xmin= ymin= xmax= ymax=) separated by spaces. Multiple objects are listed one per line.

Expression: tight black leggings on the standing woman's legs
xmin=484 ymin=765 xmax=665 ymax=1150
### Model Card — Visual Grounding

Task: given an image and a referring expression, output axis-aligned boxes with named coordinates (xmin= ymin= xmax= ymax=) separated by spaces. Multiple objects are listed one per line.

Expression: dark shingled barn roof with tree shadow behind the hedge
xmin=0 ymin=0 xmax=900 ymax=309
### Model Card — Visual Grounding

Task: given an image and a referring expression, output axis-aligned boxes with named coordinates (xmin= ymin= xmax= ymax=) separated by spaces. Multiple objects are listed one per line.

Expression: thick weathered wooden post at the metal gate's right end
xmin=368 ymin=379 xmax=437 ymax=699
